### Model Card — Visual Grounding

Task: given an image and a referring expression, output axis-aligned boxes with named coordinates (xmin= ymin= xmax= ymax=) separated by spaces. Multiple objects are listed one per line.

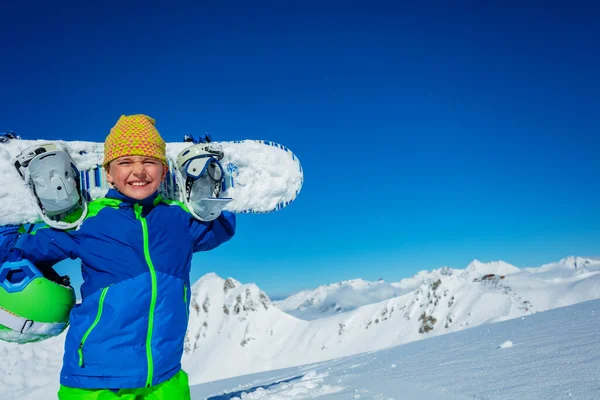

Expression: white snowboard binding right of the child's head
xmin=176 ymin=144 xmax=233 ymax=221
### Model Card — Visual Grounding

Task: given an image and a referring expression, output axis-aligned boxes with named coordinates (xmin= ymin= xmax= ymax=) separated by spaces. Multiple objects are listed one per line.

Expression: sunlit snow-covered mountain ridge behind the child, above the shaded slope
xmin=0 ymin=259 xmax=600 ymax=399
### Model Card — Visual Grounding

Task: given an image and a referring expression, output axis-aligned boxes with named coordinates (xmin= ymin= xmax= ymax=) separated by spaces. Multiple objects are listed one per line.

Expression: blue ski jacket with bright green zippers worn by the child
xmin=16 ymin=190 xmax=235 ymax=389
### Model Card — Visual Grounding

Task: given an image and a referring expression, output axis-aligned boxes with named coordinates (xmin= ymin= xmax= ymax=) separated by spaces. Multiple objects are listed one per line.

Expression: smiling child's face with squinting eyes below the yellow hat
xmin=106 ymin=156 xmax=169 ymax=200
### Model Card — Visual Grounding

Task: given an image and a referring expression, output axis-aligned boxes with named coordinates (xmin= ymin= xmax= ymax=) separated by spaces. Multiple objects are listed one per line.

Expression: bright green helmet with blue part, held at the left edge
xmin=0 ymin=260 xmax=75 ymax=343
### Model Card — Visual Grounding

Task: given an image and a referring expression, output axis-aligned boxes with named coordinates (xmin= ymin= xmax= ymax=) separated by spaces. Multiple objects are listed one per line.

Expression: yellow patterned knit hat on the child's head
xmin=102 ymin=114 xmax=167 ymax=168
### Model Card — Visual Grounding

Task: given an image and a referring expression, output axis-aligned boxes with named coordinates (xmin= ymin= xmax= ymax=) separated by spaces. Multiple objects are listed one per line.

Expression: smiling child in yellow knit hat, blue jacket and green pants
xmin=11 ymin=114 xmax=235 ymax=400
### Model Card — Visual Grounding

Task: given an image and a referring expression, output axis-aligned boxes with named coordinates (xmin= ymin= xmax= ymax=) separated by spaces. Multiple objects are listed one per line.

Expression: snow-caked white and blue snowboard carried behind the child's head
xmin=0 ymin=139 xmax=304 ymax=225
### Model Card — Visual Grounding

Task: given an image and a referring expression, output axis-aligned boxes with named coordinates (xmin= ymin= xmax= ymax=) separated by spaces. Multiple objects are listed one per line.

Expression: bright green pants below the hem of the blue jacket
xmin=58 ymin=370 xmax=190 ymax=400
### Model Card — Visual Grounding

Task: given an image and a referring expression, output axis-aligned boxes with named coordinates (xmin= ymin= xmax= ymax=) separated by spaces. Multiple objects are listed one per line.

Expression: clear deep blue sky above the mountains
xmin=0 ymin=1 xmax=600 ymax=297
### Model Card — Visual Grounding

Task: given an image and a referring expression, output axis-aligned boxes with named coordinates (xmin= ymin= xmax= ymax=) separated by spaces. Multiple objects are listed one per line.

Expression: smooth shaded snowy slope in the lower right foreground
xmin=192 ymin=300 xmax=600 ymax=400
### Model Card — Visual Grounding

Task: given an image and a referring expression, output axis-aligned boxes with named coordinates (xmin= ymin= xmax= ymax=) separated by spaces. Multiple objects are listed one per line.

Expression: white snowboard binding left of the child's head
xmin=15 ymin=143 xmax=87 ymax=230
